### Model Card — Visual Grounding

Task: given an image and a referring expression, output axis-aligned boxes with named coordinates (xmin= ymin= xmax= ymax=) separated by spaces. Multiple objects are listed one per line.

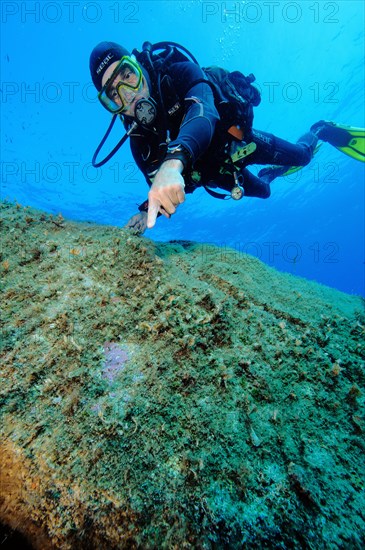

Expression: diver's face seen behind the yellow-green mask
xmin=101 ymin=61 xmax=149 ymax=117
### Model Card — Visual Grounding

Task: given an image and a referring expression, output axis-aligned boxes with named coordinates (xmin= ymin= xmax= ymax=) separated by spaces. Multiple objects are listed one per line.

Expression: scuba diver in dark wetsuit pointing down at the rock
xmin=90 ymin=42 xmax=365 ymax=234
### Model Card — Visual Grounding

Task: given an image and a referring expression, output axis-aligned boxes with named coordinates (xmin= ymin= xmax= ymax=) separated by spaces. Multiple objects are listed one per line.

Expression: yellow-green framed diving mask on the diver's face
xmin=98 ymin=56 xmax=143 ymax=114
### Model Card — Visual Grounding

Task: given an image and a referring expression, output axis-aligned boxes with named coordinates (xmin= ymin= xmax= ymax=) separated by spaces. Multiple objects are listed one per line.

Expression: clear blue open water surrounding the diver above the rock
xmin=1 ymin=0 xmax=365 ymax=295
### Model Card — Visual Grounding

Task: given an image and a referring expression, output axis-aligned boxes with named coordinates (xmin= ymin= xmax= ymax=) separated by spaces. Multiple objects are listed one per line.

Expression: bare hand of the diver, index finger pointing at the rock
xmin=147 ymin=159 xmax=185 ymax=229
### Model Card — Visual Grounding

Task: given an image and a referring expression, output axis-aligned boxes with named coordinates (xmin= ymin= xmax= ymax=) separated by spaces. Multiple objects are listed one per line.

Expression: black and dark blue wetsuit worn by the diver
xmin=125 ymin=62 xmax=318 ymax=210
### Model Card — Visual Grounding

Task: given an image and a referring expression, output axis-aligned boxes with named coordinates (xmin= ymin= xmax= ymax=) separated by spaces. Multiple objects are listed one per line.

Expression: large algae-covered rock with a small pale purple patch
xmin=0 ymin=204 xmax=365 ymax=550
